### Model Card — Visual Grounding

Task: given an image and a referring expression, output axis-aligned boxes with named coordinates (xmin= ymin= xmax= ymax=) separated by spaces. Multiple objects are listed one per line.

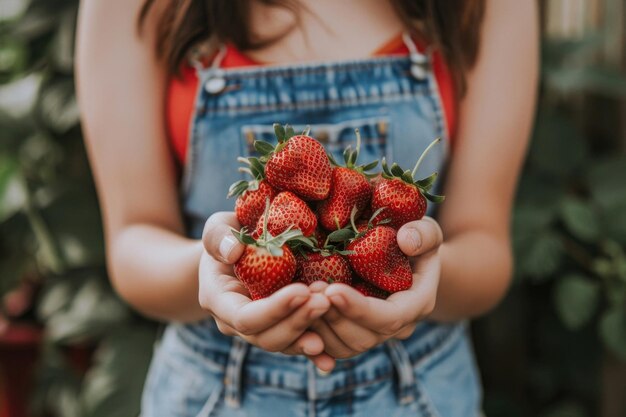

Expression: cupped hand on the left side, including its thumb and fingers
xmin=198 ymin=212 xmax=335 ymax=370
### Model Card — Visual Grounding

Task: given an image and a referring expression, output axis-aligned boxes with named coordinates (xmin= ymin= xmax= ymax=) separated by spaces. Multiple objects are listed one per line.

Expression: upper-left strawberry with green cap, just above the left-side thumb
xmin=228 ymin=158 xmax=278 ymax=230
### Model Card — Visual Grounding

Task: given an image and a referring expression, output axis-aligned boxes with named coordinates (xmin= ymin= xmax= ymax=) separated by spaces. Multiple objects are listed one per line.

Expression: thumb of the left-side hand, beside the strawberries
xmin=202 ymin=211 xmax=244 ymax=264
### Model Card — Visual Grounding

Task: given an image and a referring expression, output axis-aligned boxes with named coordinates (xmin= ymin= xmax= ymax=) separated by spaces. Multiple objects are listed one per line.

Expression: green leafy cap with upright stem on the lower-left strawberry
xmin=231 ymin=198 xmax=315 ymax=257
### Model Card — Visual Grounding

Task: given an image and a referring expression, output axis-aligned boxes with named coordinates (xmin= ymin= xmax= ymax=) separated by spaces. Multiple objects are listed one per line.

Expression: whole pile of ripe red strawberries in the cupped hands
xmin=229 ymin=124 xmax=443 ymax=300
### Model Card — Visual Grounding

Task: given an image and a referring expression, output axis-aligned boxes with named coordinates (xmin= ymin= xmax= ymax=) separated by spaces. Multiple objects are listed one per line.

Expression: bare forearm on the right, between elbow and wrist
xmin=431 ymin=230 xmax=513 ymax=321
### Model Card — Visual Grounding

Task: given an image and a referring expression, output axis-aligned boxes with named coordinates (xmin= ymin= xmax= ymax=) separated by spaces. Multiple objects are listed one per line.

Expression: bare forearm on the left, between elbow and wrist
xmin=108 ymin=224 xmax=208 ymax=321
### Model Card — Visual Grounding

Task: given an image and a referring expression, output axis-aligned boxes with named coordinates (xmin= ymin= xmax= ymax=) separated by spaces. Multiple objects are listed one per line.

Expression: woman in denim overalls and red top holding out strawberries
xmin=77 ymin=0 xmax=538 ymax=417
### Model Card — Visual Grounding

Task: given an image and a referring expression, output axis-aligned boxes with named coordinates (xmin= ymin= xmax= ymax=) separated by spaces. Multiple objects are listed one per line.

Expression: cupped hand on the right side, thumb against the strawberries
xmin=313 ymin=217 xmax=443 ymax=359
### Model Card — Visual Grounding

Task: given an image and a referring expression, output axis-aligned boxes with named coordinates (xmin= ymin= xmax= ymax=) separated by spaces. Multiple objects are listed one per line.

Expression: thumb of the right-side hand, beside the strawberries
xmin=397 ymin=217 xmax=443 ymax=256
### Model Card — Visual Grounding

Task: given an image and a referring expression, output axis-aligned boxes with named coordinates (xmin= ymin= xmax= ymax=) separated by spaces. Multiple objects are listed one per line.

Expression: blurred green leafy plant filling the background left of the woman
xmin=0 ymin=0 xmax=155 ymax=417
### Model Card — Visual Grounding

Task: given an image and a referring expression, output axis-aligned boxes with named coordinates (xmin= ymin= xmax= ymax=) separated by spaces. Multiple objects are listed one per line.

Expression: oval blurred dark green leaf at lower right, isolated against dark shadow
xmin=554 ymin=275 xmax=600 ymax=330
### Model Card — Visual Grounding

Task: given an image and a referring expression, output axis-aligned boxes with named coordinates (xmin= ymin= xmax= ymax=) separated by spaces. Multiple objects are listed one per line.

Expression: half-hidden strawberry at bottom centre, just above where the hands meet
xmin=296 ymin=252 xmax=352 ymax=285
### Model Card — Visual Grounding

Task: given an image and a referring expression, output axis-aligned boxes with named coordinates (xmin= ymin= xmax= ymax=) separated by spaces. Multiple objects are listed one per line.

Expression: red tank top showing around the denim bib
xmin=165 ymin=35 xmax=457 ymax=163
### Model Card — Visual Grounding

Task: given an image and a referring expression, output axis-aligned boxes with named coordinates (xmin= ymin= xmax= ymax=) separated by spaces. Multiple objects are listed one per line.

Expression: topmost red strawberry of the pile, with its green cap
xmin=254 ymin=124 xmax=332 ymax=200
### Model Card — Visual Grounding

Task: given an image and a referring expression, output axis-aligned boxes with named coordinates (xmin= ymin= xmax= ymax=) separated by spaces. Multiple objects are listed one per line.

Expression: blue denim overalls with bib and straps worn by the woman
xmin=142 ymin=37 xmax=481 ymax=417
